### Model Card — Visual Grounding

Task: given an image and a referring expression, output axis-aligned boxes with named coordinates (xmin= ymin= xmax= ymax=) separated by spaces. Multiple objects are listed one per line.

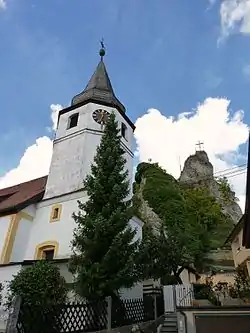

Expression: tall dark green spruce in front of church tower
xmin=70 ymin=114 xmax=139 ymax=300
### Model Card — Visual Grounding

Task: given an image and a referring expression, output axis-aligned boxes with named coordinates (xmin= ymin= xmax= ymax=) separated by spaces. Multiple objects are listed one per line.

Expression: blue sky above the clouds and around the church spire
xmin=0 ymin=0 xmax=250 ymax=208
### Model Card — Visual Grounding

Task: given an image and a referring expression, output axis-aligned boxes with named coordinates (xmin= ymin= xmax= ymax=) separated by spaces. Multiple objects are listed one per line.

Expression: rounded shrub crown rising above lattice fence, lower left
xmin=8 ymin=260 xmax=68 ymax=307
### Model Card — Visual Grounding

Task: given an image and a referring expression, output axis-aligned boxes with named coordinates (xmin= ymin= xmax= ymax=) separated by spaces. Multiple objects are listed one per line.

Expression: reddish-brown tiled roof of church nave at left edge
xmin=0 ymin=176 xmax=47 ymax=215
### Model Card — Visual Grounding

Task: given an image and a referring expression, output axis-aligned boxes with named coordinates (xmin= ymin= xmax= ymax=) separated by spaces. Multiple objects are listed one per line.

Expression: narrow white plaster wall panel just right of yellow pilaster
xmin=10 ymin=218 xmax=33 ymax=262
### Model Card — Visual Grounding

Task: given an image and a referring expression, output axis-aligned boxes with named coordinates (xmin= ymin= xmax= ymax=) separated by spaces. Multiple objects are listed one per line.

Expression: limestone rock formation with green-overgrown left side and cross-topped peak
xmin=133 ymin=151 xmax=239 ymax=272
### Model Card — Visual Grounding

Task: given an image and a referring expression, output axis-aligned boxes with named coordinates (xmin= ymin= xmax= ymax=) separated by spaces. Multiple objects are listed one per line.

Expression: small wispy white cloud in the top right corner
xmin=220 ymin=0 xmax=250 ymax=37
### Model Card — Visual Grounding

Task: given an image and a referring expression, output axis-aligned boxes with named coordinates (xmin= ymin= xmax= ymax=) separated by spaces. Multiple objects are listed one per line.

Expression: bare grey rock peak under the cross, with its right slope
xmin=179 ymin=151 xmax=242 ymax=224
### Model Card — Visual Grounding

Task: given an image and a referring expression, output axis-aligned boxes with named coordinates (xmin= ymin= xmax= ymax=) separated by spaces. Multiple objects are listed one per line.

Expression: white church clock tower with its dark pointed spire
xmin=44 ymin=44 xmax=135 ymax=199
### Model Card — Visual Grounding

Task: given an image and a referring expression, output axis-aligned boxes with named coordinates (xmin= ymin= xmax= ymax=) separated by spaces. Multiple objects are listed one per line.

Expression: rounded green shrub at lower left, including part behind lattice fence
xmin=7 ymin=260 xmax=68 ymax=333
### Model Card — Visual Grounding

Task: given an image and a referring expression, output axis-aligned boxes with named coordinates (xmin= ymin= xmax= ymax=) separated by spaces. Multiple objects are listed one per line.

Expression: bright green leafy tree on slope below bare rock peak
xmin=169 ymin=188 xmax=228 ymax=276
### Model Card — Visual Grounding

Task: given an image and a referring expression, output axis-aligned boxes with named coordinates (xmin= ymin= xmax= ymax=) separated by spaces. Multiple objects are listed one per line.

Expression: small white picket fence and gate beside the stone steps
xmin=163 ymin=284 xmax=194 ymax=312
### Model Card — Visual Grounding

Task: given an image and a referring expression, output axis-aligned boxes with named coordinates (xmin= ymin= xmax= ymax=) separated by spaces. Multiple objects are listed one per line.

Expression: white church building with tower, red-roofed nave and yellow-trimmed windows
xmin=0 ymin=49 xmax=143 ymax=304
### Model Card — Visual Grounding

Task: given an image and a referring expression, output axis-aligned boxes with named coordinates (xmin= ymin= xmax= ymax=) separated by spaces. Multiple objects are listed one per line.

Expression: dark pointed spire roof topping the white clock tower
xmin=71 ymin=47 xmax=125 ymax=112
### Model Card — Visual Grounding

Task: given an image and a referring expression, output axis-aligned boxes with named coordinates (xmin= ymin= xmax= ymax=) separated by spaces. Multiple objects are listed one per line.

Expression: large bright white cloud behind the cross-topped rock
xmin=135 ymin=98 xmax=248 ymax=210
